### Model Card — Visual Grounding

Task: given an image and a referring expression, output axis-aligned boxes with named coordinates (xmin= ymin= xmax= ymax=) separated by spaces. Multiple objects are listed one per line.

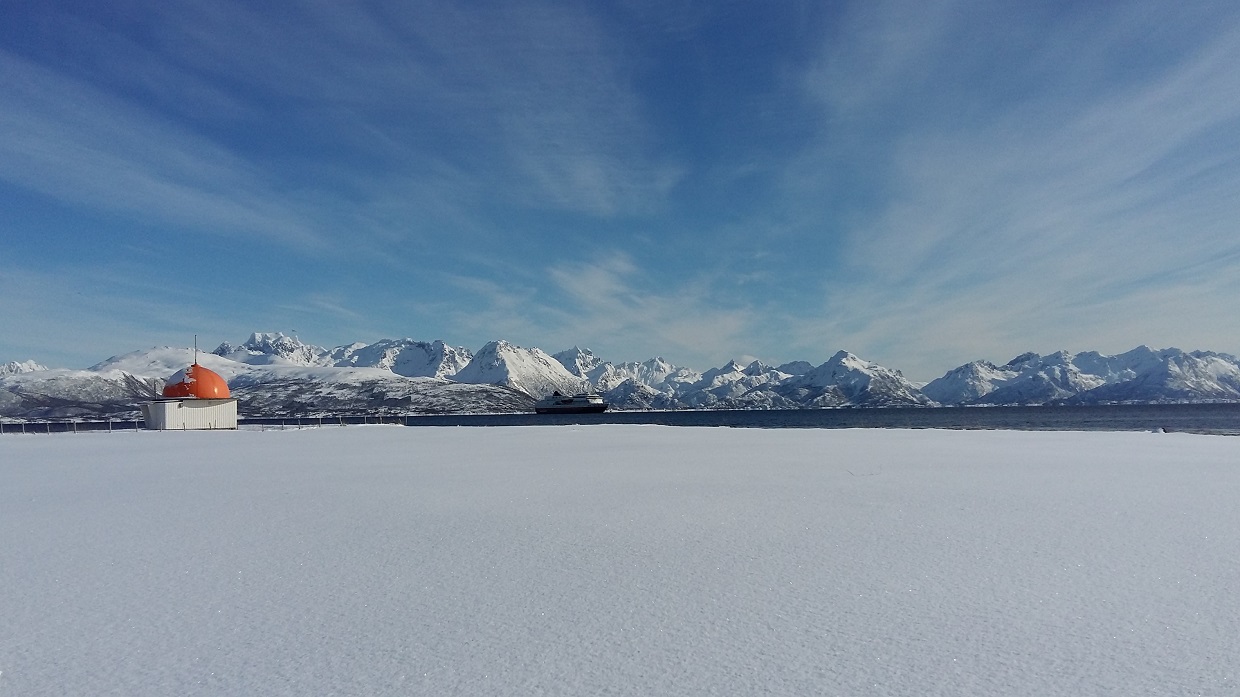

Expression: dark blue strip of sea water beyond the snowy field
xmin=402 ymin=404 xmax=1240 ymax=434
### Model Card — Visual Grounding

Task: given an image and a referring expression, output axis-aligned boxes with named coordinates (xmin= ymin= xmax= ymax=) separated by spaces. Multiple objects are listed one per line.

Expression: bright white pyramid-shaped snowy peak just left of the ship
xmin=453 ymin=341 xmax=590 ymax=398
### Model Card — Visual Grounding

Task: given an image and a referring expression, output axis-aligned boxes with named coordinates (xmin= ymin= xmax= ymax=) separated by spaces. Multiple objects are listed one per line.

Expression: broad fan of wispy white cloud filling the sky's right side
xmin=778 ymin=2 xmax=1240 ymax=378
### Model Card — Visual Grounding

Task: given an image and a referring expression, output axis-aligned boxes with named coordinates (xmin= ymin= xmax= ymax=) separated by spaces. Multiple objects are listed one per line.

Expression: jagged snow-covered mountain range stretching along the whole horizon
xmin=0 ymin=332 xmax=1240 ymax=419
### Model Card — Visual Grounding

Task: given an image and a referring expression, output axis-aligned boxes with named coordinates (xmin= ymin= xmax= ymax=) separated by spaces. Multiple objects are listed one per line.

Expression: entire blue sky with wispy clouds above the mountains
xmin=0 ymin=0 xmax=1240 ymax=381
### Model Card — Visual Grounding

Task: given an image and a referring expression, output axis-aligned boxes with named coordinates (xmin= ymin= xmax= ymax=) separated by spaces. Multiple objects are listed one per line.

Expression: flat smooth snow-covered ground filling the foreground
xmin=0 ymin=425 xmax=1240 ymax=697
